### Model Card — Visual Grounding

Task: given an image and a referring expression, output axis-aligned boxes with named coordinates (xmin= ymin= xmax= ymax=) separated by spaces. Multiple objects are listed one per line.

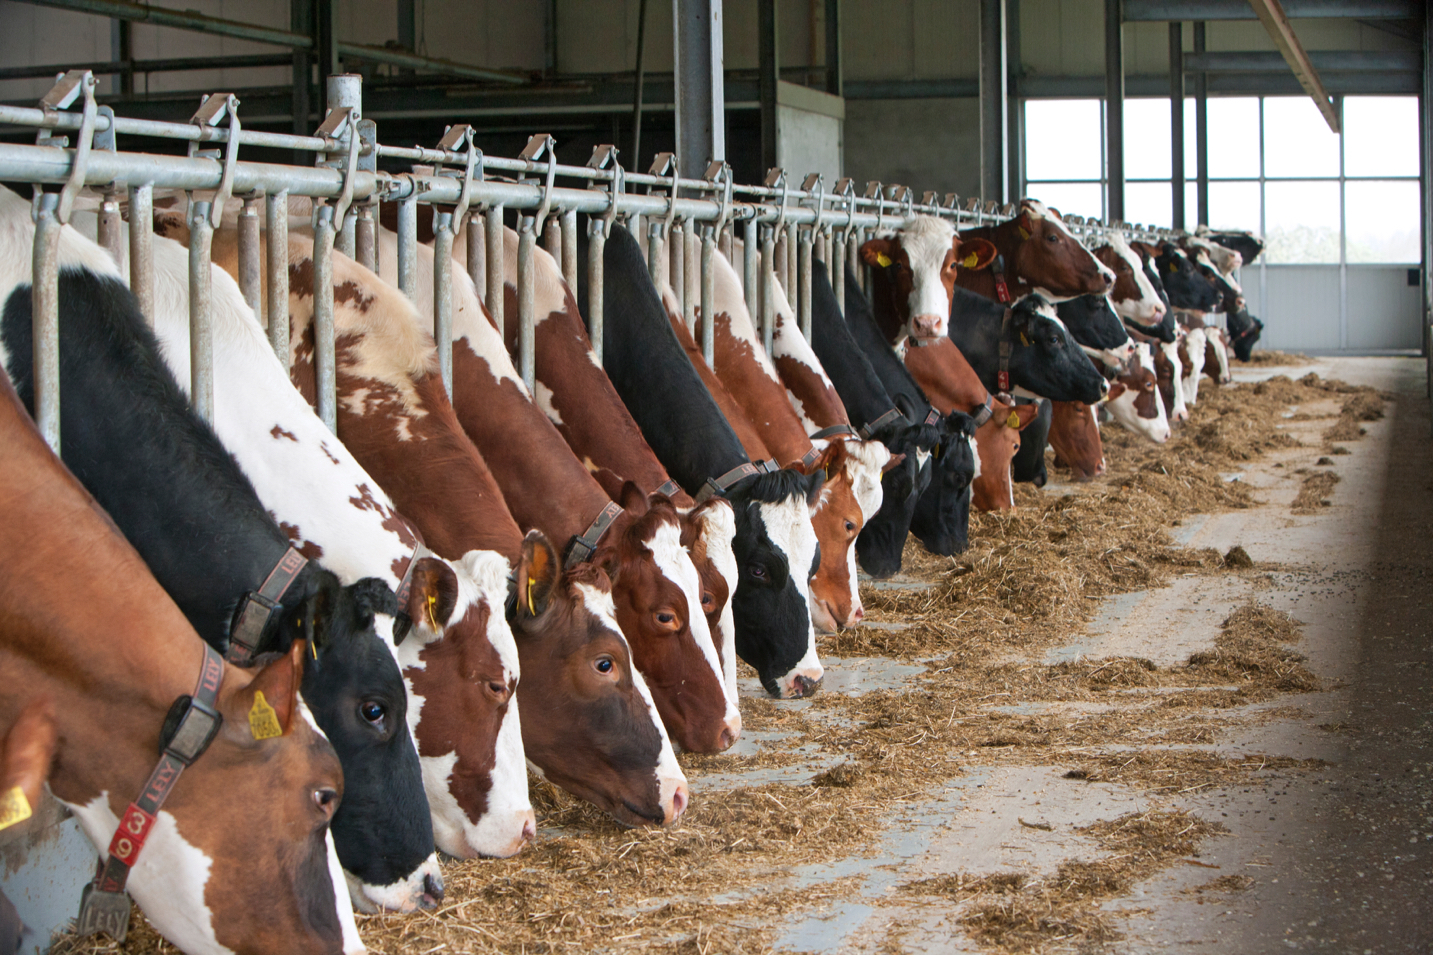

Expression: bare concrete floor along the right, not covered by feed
xmin=778 ymin=358 xmax=1433 ymax=955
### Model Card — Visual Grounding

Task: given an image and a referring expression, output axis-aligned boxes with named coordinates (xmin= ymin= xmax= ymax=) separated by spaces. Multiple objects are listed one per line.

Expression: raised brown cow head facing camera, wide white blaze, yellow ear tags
xmin=861 ymin=215 xmax=995 ymax=344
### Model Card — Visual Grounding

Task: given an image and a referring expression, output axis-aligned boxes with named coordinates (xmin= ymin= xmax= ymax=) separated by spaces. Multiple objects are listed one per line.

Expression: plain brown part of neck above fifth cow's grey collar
xmin=453 ymin=338 xmax=612 ymax=559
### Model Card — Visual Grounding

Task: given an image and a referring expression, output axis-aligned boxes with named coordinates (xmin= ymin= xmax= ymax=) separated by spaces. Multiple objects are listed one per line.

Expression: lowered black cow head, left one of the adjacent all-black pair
xmin=856 ymin=413 xmax=941 ymax=578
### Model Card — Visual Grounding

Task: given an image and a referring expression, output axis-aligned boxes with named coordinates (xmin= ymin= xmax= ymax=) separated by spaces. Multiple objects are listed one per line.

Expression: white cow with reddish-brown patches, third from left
xmin=128 ymin=217 xmax=535 ymax=871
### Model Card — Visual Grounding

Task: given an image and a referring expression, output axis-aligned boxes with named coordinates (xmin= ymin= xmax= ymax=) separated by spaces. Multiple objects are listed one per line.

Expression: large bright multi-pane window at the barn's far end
xmin=1025 ymin=96 xmax=1420 ymax=264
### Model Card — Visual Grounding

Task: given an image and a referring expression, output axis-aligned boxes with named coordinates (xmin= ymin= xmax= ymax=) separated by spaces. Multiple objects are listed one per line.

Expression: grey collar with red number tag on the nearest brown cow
xmin=75 ymin=644 xmax=224 ymax=942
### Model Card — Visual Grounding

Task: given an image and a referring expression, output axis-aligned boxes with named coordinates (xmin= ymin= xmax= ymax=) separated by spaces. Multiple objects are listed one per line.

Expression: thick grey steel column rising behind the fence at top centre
xmin=672 ymin=0 xmax=727 ymax=171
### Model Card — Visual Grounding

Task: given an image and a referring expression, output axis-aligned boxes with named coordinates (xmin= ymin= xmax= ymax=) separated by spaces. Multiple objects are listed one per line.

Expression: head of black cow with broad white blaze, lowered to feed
xmin=725 ymin=470 xmax=825 ymax=698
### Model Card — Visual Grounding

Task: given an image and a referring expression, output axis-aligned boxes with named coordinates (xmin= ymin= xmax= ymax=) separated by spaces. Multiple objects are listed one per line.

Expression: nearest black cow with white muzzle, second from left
xmin=0 ymin=220 xmax=443 ymax=911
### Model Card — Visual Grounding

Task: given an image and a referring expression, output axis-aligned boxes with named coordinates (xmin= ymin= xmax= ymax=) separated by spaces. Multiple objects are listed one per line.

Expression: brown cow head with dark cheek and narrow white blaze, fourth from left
xmin=510 ymin=531 xmax=688 ymax=826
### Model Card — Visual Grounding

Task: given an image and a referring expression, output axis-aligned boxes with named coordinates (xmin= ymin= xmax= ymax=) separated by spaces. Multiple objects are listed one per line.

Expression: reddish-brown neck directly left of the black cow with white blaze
xmin=503 ymin=268 xmax=692 ymax=506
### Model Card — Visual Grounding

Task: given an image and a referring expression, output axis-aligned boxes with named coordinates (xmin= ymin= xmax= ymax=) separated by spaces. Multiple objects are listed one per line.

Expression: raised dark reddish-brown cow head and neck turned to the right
xmin=956 ymin=199 xmax=1115 ymax=303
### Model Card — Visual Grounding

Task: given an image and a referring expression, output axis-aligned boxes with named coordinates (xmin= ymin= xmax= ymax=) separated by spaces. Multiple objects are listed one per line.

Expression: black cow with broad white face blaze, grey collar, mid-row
xmin=579 ymin=227 xmax=824 ymax=697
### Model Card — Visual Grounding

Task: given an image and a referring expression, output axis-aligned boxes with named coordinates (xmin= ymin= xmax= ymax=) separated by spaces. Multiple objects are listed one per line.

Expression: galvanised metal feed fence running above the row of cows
xmin=0 ymin=70 xmax=1178 ymax=450
